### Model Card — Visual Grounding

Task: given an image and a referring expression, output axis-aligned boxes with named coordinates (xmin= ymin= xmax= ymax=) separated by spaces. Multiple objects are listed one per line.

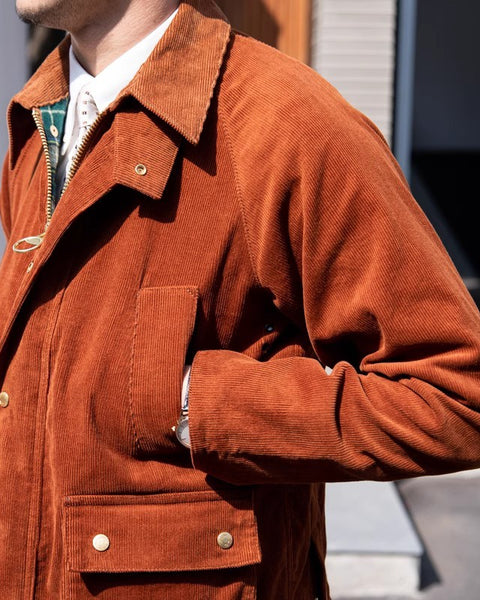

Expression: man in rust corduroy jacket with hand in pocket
xmin=0 ymin=0 xmax=480 ymax=600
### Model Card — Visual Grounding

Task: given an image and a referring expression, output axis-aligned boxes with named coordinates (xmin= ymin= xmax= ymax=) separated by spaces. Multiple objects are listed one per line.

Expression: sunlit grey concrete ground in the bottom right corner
xmin=338 ymin=470 xmax=480 ymax=600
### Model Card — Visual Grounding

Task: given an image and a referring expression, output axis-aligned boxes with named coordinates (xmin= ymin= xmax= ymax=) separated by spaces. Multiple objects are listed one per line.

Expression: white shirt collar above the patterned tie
xmin=63 ymin=8 xmax=178 ymax=144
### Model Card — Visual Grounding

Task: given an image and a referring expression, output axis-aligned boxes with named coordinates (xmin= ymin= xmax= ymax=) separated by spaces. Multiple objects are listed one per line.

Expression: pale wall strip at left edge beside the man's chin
xmin=0 ymin=0 xmax=28 ymax=251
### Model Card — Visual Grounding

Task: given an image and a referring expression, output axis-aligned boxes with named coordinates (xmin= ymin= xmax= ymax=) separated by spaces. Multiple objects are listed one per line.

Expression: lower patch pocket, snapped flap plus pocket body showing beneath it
xmin=64 ymin=490 xmax=261 ymax=600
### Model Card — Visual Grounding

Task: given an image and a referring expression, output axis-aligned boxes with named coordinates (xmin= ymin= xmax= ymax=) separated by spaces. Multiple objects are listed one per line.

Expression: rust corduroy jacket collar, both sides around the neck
xmin=10 ymin=0 xmax=230 ymax=144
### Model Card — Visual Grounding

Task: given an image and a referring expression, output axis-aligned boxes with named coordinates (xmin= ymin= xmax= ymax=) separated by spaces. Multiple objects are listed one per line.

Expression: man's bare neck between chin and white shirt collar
xmin=70 ymin=0 xmax=180 ymax=77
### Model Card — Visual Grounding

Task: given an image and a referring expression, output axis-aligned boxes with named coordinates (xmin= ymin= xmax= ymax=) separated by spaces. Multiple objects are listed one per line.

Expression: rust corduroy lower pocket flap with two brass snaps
xmin=64 ymin=490 xmax=261 ymax=573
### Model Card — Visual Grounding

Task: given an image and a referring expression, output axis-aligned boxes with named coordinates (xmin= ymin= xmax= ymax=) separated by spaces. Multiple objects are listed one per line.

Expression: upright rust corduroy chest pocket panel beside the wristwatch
xmin=129 ymin=286 xmax=198 ymax=455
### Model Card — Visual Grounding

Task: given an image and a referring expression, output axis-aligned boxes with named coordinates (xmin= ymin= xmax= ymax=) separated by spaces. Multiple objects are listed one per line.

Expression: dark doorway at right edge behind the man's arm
xmin=411 ymin=0 xmax=480 ymax=302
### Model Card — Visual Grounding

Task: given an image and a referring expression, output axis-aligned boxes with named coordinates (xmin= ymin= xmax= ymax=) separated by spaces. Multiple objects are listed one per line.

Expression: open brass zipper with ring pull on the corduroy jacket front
xmin=13 ymin=108 xmax=102 ymax=254
